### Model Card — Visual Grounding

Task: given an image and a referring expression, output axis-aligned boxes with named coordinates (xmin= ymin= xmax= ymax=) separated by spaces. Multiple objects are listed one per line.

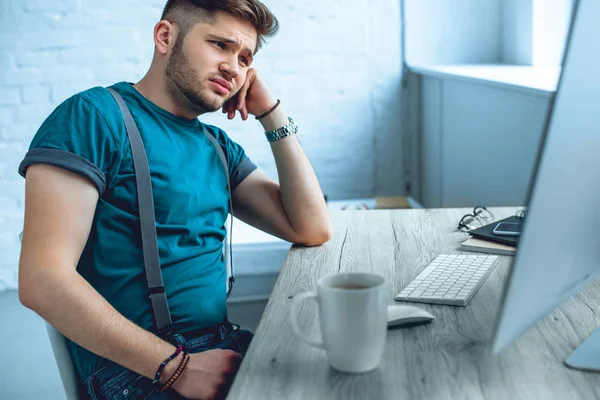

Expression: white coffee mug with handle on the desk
xmin=290 ymin=272 xmax=387 ymax=373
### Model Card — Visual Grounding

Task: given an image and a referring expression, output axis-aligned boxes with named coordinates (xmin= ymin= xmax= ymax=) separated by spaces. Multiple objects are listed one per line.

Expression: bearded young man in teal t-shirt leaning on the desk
xmin=19 ymin=0 xmax=332 ymax=399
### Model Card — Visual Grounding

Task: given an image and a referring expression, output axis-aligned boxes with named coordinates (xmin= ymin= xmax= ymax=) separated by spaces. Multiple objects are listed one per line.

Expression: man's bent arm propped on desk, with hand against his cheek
xmin=225 ymin=71 xmax=333 ymax=246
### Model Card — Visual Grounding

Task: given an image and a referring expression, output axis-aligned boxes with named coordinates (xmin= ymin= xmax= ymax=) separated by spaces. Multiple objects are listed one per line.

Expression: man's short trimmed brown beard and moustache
xmin=165 ymin=37 xmax=235 ymax=115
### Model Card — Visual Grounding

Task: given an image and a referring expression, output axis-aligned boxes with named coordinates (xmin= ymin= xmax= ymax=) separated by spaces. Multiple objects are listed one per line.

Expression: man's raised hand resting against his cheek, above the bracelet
xmin=223 ymin=68 xmax=277 ymax=121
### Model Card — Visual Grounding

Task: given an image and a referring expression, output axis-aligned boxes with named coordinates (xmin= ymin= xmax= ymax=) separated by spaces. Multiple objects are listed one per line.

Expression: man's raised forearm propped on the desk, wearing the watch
xmin=260 ymin=106 xmax=332 ymax=243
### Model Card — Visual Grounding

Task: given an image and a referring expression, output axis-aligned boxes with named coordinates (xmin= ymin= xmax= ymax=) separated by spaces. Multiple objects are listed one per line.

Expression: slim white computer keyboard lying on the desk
xmin=396 ymin=254 xmax=498 ymax=306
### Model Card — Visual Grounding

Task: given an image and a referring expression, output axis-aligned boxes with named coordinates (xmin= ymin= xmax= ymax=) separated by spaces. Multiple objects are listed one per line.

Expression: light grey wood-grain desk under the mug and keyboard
xmin=228 ymin=208 xmax=600 ymax=400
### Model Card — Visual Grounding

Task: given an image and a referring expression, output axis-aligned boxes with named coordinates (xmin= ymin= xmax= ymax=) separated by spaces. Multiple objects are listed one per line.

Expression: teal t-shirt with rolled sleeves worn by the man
xmin=19 ymin=82 xmax=256 ymax=380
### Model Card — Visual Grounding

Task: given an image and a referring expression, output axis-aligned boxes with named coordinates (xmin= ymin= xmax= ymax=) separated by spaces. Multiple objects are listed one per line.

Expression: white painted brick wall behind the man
xmin=0 ymin=0 xmax=403 ymax=290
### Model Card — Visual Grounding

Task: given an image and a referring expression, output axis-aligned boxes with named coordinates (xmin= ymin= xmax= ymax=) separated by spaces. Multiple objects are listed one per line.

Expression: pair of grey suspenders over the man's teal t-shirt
xmin=107 ymin=88 xmax=235 ymax=335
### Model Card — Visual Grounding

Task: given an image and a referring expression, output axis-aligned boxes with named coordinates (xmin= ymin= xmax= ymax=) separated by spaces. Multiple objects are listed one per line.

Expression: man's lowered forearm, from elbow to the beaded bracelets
xmin=22 ymin=268 xmax=175 ymax=378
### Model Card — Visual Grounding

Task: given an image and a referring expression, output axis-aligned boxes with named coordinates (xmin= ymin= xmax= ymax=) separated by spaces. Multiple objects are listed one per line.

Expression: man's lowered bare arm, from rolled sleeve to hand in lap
xmin=19 ymin=164 xmax=240 ymax=398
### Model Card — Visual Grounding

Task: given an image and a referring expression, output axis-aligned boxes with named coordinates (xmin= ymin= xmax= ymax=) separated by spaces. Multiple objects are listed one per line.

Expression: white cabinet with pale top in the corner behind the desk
xmin=413 ymin=67 xmax=558 ymax=208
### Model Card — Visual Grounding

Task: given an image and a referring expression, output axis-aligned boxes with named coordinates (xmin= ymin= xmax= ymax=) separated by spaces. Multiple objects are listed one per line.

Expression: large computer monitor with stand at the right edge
xmin=492 ymin=0 xmax=600 ymax=371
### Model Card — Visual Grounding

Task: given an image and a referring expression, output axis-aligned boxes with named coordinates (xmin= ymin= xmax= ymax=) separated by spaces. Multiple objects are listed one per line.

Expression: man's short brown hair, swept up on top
xmin=161 ymin=0 xmax=279 ymax=53
